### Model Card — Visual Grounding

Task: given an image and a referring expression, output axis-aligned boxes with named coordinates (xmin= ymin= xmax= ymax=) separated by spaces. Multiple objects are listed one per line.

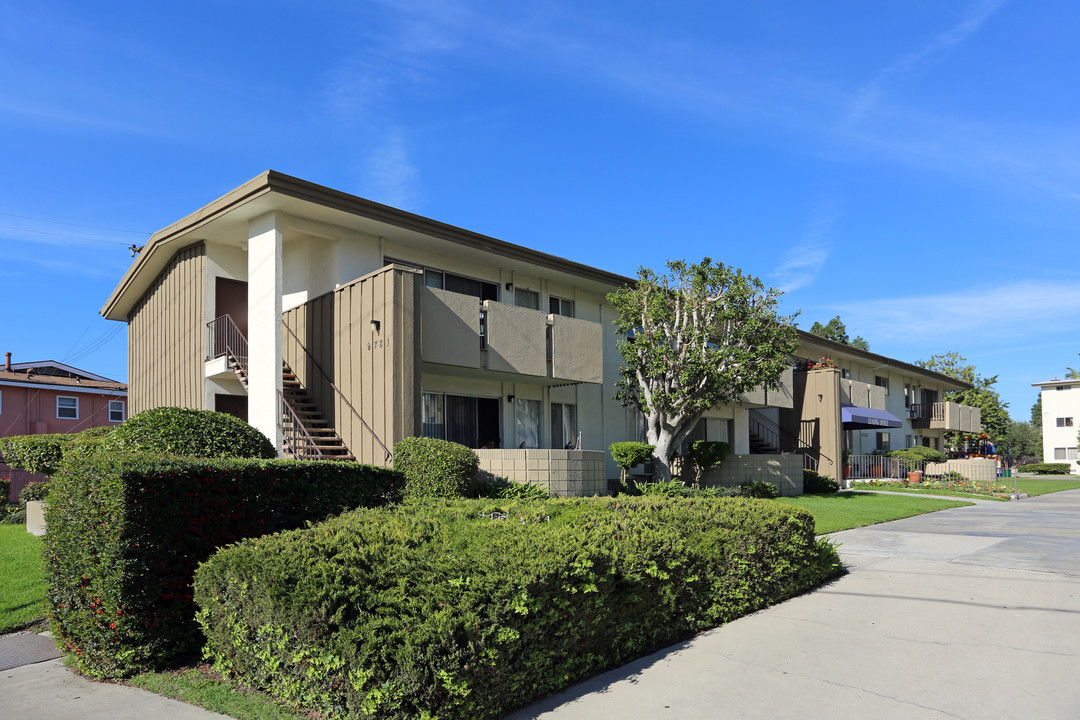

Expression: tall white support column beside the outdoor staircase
xmin=247 ymin=213 xmax=282 ymax=453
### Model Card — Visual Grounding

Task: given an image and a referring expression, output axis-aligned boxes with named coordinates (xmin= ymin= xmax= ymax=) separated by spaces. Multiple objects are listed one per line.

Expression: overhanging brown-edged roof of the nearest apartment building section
xmin=100 ymin=171 xmax=634 ymax=321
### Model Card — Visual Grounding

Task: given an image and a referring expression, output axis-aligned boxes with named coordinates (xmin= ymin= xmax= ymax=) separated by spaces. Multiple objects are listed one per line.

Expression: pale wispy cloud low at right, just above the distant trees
xmin=827 ymin=275 xmax=1080 ymax=347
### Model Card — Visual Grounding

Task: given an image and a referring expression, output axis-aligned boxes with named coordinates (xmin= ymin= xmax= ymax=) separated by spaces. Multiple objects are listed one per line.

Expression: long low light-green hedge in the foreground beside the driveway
xmin=195 ymin=497 xmax=840 ymax=718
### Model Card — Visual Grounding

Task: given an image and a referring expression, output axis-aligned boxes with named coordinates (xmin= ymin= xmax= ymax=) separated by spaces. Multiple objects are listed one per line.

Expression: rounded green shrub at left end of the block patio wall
xmin=394 ymin=437 xmax=480 ymax=498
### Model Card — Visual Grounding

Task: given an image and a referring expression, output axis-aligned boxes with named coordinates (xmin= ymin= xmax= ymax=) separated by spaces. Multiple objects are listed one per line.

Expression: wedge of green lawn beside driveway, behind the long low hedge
xmin=777 ymin=492 xmax=972 ymax=534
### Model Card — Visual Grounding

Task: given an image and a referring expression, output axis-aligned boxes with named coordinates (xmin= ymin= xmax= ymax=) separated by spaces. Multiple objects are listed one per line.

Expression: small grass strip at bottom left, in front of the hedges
xmin=127 ymin=666 xmax=311 ymax=720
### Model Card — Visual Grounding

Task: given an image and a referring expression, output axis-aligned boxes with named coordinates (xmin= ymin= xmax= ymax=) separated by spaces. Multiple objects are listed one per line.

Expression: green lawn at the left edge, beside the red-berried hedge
xmin=0 ymin=525 xmax=45 ymax=634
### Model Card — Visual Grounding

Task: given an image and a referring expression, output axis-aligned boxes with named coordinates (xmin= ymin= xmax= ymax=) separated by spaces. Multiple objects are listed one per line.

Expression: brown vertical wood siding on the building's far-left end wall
xmin=127 ymin=243 xmax=206 ymax=415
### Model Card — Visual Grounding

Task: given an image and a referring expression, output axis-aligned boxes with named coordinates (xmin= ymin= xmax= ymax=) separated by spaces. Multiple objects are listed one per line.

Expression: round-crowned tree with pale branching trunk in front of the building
xmin=607 ymin=258 xmax=798 ymax=480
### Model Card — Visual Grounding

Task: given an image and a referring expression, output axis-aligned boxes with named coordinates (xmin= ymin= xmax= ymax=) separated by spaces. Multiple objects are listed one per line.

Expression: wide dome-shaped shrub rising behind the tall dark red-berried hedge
xmin=100 ymin=407 xmax=278 ymax=459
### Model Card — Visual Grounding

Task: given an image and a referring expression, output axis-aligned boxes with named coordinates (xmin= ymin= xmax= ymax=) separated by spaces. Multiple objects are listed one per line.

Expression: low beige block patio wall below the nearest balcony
xmin=476 ymin=449 xmax=607 ymax=498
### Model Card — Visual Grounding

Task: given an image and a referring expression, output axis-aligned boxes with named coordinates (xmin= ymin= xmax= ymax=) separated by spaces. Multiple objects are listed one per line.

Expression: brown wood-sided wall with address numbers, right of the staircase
xmin=282 ymin=266 xmax=422 ymax=465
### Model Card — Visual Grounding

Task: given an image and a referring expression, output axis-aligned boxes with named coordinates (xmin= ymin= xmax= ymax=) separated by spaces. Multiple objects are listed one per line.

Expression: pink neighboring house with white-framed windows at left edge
xmin=0 ymin=353 xmax=127 ymax=502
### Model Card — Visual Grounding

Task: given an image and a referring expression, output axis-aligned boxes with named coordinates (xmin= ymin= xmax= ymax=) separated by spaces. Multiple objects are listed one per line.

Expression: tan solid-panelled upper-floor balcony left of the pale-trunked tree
xmin=420 ymin=287 xmax=604 ymax=383
